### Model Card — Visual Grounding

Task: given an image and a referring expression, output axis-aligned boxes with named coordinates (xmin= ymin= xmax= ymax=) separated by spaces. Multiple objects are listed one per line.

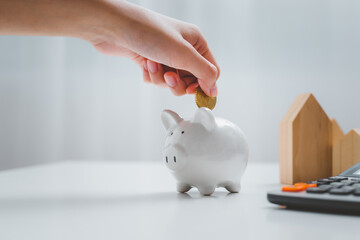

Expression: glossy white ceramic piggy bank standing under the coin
xmin=161 ymin=108 xmax=249 ymax=195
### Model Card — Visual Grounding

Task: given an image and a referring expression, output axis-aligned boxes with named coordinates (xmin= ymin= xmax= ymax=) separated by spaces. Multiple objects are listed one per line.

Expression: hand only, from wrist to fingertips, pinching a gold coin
xmin=86 ymin=2 xmax=220 ymax=96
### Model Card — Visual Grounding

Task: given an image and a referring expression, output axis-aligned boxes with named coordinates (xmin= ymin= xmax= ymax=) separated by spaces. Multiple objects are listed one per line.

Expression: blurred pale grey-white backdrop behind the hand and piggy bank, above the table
xmin=0 ymin=0 xmax=360 ymax=169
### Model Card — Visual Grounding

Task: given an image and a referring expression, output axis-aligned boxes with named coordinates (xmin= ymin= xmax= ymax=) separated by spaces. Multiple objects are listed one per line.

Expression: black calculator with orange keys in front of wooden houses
xmin=267 ymin=162 xmax=360 ymax=214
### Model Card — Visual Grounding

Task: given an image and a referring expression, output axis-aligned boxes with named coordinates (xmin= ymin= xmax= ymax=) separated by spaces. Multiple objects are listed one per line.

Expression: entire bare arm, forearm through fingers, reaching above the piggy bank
xmin=0 ymin=0 xmax=220 ymax=96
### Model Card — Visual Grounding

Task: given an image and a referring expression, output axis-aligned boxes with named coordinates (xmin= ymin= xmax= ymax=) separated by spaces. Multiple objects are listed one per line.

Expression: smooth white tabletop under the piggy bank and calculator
xmin=0 ymin=161 xmax=360 ymax=240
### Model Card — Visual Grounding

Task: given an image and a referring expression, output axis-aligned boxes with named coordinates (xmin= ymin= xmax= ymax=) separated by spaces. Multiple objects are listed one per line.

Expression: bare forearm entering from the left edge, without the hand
xmin=0 ymin=0 xmax=128 ymax=39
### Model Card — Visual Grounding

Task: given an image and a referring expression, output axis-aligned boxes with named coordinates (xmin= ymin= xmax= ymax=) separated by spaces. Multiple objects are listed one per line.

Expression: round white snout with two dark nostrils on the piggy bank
xmin=164 ymin=144 xmax=186 ymax=171
